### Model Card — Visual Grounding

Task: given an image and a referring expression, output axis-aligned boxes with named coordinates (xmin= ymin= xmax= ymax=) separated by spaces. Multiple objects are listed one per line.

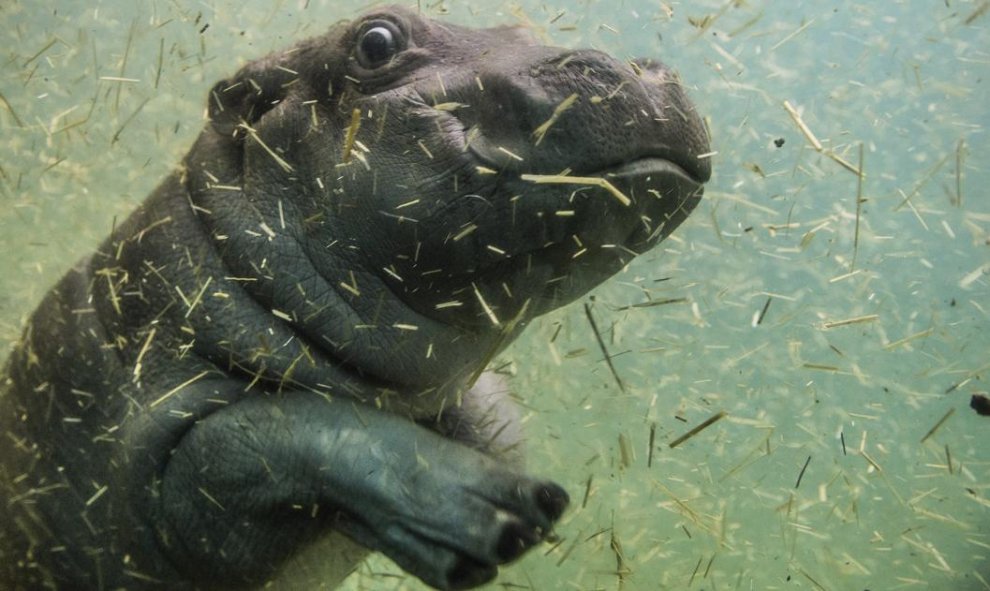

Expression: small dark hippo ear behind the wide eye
xmin=208 ymin=59 xmax=293 ymax=137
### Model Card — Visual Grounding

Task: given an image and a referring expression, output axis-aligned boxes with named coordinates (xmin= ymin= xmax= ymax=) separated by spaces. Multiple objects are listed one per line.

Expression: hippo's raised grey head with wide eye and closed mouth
xmin=186 ymin=2 xmax=710 ymax=400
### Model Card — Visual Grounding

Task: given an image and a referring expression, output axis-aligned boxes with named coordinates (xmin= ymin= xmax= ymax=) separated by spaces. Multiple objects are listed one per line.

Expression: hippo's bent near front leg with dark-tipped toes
xmin=158 ymin=392 xmax=568 ymax=589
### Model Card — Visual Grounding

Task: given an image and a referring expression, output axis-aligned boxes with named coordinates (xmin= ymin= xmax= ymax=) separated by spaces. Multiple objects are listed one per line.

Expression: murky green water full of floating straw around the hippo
xmin=0 ymin=0 xmax=990 ymax=591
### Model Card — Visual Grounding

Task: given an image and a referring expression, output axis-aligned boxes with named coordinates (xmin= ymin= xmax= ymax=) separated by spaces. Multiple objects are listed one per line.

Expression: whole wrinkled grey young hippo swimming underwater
xmin=0 ymin=8 xmax=709 ymax=589
